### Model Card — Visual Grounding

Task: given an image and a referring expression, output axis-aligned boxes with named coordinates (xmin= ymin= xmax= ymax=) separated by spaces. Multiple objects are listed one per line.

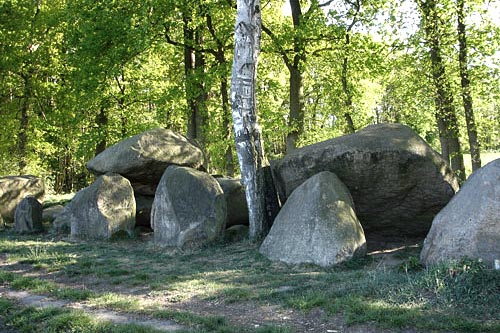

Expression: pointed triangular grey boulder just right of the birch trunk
xmin=260 ymin=171 xmax=366 ymax=267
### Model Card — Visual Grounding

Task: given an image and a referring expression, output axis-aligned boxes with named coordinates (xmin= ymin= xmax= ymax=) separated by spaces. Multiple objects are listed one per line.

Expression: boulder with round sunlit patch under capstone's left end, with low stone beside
xmin=54 ymin=173 xmax=136 ymax=240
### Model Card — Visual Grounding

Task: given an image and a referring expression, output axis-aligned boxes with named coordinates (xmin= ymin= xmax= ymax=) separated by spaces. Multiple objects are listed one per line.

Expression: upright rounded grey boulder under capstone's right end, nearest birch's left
xmin=151 ymin=166 xmax=226 ymax=247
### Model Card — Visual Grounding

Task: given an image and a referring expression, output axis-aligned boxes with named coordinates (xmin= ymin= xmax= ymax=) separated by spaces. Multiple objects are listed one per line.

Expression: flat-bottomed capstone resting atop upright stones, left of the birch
xmin=87 ymin=128 xmax=204 ymax=195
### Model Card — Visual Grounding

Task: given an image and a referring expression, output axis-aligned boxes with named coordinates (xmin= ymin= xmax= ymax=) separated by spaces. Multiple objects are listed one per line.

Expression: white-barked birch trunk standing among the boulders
xmin=231 ymin=0 xmax=268 ymax=239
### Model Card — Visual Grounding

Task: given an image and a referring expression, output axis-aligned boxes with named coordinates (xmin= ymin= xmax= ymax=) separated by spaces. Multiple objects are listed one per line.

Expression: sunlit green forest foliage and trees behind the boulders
xmin=0 ymin=0 xmax=500 ymax=192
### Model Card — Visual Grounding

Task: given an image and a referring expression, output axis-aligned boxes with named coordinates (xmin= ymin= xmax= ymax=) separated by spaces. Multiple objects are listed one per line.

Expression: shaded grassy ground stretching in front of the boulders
xmin=0 ymin=230 xmax=500 ymax=333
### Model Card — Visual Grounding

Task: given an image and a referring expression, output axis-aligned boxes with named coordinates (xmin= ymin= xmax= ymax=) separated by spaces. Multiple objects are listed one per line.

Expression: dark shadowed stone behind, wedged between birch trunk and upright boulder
xmin=216 ymin=178 xmax=248 ymax=228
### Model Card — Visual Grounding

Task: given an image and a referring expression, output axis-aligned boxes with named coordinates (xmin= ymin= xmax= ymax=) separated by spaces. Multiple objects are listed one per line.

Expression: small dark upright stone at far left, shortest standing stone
xmin=14 ymin=196 xmax=43 ymax=234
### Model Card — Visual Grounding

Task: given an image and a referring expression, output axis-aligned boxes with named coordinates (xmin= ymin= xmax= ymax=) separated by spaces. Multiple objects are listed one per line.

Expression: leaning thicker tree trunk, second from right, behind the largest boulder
xmin=418 ymin=0 xmax=465 ymax=181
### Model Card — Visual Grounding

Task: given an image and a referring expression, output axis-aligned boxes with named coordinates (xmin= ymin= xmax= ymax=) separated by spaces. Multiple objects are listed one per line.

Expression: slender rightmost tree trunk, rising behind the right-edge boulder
xmin=457 ymin=0 xmax=481 ymax=171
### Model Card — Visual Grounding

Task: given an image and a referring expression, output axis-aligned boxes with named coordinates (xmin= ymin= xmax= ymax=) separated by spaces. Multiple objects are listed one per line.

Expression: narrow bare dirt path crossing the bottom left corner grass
xmin=0 ymin=286 xmax=184 ymax=332
